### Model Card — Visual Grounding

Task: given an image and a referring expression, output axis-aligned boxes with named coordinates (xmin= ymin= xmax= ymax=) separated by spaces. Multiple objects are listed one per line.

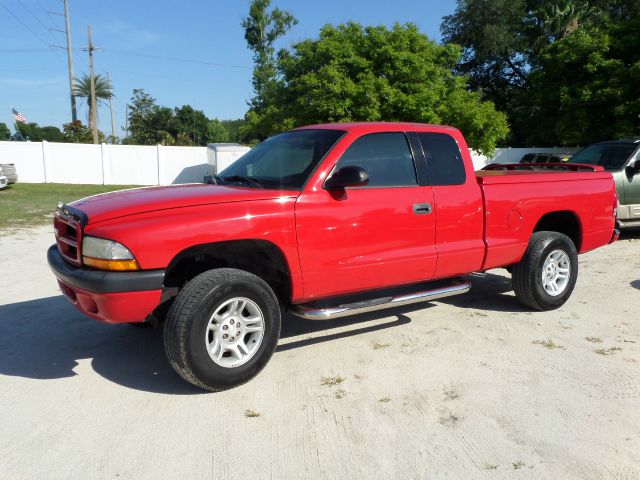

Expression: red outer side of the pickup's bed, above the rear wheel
xmin=476 ymin=170 xmax=616 ymax=270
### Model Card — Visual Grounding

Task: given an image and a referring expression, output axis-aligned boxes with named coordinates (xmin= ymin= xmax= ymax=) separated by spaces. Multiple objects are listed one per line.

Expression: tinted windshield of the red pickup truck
xmin=219 ymin=129 xmax=344 ymax=190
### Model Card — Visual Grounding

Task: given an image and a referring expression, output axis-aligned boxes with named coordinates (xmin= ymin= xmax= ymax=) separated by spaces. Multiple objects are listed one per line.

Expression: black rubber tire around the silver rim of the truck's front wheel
xmin=164 ymin=268 xmax=280 ymax=392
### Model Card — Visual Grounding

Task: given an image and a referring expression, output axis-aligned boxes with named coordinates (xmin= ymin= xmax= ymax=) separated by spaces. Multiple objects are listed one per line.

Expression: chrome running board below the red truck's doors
xmin=289 ymin=278 xmax=471 ymax=320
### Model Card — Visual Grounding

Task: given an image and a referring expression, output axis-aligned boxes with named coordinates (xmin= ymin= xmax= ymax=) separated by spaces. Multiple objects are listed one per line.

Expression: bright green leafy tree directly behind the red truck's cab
xmin=242 ymin=23 xmax=508 ymax=153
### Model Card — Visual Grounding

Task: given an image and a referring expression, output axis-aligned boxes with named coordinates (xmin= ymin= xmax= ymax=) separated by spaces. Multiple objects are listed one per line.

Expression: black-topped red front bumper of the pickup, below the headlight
xmin=47 ymin=245 xmax=164 ymax=323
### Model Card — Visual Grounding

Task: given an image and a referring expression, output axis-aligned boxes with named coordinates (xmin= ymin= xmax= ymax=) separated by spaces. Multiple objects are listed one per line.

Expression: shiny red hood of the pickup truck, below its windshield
xmin=69 ymin=183 xmax=300 ymax=224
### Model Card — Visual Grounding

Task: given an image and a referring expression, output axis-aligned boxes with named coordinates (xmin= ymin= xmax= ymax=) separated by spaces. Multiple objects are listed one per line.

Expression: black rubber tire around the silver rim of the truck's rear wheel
xmin=512 ymin=232 xmax=578 ymax=310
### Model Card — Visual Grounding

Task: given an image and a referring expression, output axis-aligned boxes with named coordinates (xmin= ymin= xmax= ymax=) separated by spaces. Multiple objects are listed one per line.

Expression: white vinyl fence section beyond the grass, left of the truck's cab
xmin=0 ymin=142 xmax=213 ymax=185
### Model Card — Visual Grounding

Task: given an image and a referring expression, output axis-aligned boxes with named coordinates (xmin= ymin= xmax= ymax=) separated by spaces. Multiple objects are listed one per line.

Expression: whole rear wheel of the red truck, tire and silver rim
xmin=512 ymin=232 xmax=578 ymax=310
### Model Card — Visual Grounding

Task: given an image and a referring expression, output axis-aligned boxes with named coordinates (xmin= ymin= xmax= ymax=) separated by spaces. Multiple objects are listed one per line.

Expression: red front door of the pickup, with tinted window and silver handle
xmin=296 ymin=127 xmax=436 ymax=300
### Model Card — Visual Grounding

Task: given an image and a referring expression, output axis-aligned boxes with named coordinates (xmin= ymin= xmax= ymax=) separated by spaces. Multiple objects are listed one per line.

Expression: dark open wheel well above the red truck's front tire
xmin=164 ymin=240 xmax=291 ymax=305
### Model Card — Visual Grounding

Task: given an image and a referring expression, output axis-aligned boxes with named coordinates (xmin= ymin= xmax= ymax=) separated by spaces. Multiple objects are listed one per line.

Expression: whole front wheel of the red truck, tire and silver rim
xmin=164 ymin=268 xmax=280 ymax=391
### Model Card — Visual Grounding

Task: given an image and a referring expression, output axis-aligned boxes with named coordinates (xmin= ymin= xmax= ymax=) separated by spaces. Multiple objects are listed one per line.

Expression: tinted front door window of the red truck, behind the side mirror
xmin=336 ymin=132 xmax=418 ymax=187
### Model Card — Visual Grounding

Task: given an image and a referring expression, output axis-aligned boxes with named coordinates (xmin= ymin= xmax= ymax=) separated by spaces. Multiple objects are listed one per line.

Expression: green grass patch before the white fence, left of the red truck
xmin=0 ymin=182 xmax=141 ymax=233
